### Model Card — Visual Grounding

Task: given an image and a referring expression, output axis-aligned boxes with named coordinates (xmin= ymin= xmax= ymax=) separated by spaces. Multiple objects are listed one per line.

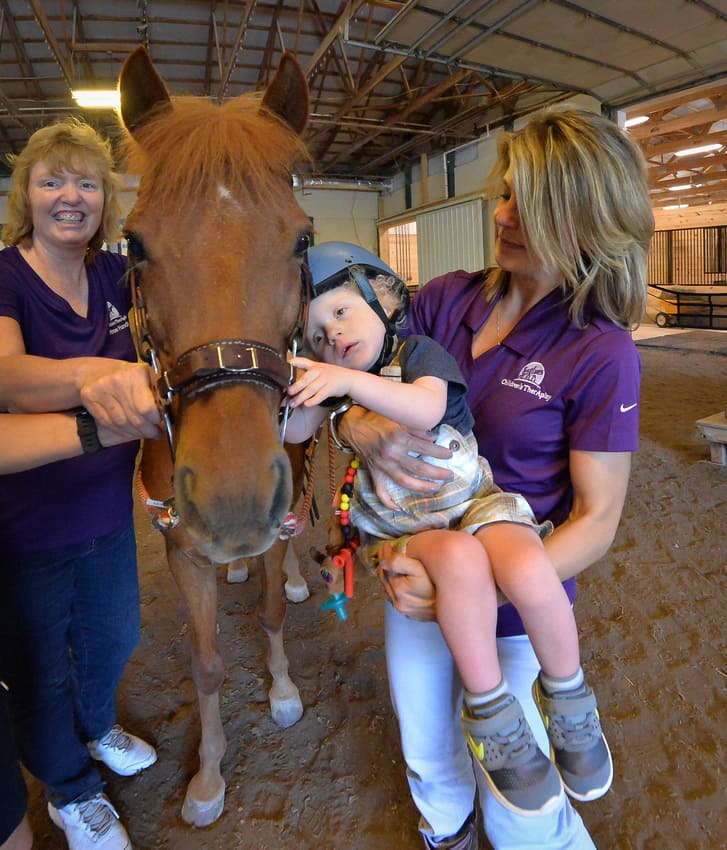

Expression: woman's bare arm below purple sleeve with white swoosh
xmin=544 ymin=451 xmax=631 ymax=581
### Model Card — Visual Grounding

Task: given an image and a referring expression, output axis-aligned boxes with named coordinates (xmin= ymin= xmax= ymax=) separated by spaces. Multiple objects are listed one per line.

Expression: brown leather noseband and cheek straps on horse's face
xmin=126 ymin=261 xmax=311 ymax=460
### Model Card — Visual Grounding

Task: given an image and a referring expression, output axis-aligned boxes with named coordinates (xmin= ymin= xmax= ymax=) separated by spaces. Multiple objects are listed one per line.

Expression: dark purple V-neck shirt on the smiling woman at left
xmin=0 ymin=242 xmax=139 ymax=555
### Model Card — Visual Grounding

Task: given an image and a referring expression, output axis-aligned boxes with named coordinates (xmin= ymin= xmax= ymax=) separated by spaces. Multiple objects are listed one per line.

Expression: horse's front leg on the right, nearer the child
xmin=258 ymin=541 xmax=303 ymax=728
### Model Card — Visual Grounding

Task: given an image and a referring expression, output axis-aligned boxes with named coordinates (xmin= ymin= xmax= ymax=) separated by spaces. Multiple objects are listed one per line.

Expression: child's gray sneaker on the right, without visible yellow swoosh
xmin=533 ymin=677 xmax=613 ymax=803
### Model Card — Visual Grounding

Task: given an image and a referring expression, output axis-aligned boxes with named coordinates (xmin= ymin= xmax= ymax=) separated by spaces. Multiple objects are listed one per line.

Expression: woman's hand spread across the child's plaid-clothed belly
xmin=338 ymin=406 xmax=452 ymax=510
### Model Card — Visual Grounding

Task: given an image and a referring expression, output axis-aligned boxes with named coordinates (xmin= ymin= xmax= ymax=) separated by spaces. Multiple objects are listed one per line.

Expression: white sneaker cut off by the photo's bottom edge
xmin=48 ymin=792 xmax=132 ymax=850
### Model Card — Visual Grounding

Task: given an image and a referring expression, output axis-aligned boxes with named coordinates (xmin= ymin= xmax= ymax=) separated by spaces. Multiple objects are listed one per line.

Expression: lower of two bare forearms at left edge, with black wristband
xmin=0 ymin=413 xmax=149 ymax=475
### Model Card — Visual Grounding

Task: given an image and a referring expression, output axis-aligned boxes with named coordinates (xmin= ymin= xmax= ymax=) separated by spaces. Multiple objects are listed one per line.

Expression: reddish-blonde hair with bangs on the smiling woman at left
xmin=3 ymin=118 xmax=121 ymax=263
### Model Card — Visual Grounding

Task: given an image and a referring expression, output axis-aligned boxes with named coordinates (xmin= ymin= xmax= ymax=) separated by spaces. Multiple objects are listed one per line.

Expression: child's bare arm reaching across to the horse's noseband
xmin=288 ymin=357 xmax=447 ymax=431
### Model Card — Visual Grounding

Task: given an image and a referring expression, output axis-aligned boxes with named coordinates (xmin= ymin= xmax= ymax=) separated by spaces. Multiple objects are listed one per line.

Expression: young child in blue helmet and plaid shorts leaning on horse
xmin=286 ymin=243 xmax=613 ymax=815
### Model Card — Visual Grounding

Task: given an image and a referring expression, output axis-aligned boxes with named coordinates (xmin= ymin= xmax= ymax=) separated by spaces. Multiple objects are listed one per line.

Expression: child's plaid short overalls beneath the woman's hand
xmin=351 ymin=425 xmax=553 ymax=549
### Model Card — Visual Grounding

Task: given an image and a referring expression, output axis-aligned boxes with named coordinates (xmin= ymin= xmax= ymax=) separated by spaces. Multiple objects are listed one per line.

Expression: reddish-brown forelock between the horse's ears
xmin=120 ymin=93 xmax=308 ymax=203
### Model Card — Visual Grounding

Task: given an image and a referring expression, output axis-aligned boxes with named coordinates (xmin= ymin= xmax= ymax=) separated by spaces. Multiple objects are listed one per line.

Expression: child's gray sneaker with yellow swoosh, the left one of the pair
xmin=462 ymin=694 xmax=563 ymax=815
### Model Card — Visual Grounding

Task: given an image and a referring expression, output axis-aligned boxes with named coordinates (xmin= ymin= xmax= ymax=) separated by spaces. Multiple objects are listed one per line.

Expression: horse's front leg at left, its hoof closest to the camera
xmin=166 ymin=537 xmax=227 ymax=827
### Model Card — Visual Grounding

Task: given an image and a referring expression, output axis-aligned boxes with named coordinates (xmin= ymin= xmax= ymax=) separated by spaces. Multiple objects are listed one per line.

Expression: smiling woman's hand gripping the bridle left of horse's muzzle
xmin=80 ymin=361 xmax=161 ymax=438
